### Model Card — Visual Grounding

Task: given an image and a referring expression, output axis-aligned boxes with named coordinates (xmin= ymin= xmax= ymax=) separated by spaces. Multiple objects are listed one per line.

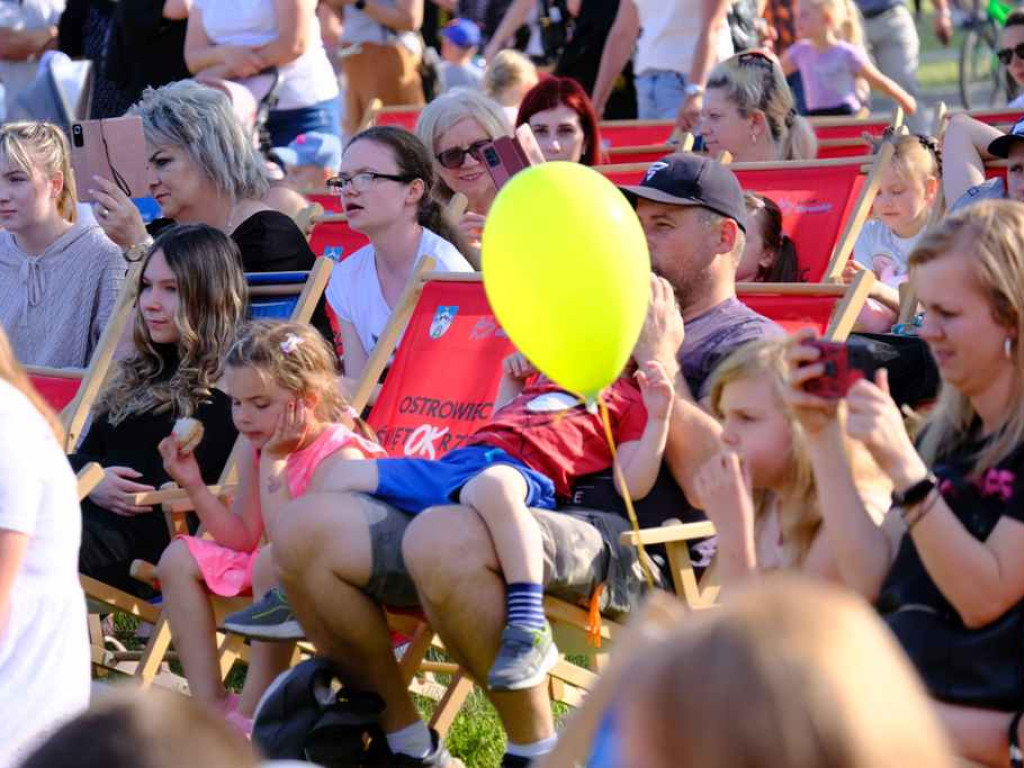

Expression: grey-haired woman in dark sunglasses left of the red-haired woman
xmin=416 ymin=88 xmax=512 ymax=244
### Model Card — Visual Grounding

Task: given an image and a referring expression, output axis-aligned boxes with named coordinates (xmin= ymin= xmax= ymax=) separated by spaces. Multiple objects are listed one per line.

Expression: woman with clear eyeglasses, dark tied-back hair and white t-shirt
xmin=327 ymin=126 xmax=473 ymax=381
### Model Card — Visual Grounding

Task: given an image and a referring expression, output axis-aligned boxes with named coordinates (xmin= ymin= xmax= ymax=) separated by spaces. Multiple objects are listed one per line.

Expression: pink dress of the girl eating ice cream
xmin=177 ymin=424 xmax=387 ymax=597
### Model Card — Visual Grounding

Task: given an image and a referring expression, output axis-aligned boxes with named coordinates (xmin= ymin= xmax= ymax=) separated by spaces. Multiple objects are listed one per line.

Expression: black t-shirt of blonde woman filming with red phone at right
xmin=878 ymin=440 xmax=1024 ymax=616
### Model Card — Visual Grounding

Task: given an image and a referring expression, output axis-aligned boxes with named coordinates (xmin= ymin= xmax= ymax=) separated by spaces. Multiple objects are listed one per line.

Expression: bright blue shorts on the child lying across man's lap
xmin=374 ymin=445 xmax=555 ymax=514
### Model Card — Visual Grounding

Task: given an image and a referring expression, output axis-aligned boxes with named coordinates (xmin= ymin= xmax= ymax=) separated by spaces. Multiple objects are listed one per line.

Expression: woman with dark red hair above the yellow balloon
xmin=516 ymin=77 xmax=603 ymax=165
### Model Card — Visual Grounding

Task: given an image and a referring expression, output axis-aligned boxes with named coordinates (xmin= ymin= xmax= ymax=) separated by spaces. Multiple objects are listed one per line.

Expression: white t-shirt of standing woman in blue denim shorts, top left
xmin=195 ymin=0 xmax=338 ymax=111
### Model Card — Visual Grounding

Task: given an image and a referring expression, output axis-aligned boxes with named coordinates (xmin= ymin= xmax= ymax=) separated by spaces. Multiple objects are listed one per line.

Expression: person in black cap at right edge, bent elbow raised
xmin=942 ymin=115 xmax=1024 ymax=213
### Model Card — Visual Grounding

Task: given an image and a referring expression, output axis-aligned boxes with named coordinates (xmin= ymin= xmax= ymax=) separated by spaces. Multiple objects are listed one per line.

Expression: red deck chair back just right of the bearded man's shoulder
xmin=736 ymin=271 xmax=874 ymax=341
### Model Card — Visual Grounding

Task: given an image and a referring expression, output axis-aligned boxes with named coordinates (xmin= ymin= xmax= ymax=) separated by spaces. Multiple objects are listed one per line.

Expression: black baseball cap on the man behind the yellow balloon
xmin=618 ymin=152 xmax=746 ymax=232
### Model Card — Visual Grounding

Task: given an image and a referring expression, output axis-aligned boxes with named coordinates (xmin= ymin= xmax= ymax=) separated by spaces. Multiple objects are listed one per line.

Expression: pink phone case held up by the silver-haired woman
xmin=71 ymin=115 xmax=150 ymax=203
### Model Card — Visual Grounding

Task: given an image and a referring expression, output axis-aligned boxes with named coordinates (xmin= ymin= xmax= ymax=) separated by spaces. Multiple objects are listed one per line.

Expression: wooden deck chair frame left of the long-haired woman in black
xmin=26 ymin=263 xmax=142 ymax=454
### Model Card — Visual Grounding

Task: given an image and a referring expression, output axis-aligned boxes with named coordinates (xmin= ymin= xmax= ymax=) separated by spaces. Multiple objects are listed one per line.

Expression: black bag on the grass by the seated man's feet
xmin=252 ymin=658 xmax=384 ymax=768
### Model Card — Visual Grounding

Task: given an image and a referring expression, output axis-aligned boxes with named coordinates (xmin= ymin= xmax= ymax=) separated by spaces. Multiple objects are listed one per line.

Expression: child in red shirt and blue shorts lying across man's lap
xmin=237 ymin=346 xmax=673 ymax=691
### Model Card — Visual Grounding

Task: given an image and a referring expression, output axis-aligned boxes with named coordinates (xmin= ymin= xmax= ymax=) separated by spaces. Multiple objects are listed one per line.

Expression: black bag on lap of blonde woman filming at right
xmin=884 ymin=603 xmax=1024 ymax=712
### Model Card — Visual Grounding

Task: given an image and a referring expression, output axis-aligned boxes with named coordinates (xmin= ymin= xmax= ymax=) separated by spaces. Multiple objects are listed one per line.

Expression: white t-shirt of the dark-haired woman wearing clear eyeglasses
xmin=327 ymin=228 xmax=473 ymax=354
